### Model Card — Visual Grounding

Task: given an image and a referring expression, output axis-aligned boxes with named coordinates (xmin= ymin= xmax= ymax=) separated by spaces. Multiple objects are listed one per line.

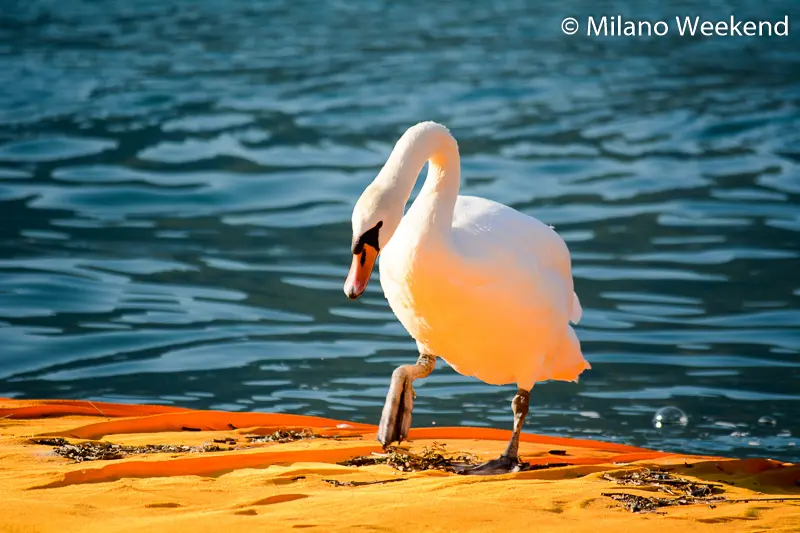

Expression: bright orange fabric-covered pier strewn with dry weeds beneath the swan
xmin=0 ymin=399 xmax=800 ymax=533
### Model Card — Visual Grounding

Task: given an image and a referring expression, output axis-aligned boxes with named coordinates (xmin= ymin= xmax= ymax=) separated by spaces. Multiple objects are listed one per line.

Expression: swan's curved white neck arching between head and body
xmin=381 ymin=122 xmax=461 ymax=232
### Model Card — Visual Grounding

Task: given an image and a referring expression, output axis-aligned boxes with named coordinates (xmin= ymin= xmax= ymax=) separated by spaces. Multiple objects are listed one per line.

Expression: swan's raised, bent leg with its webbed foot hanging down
xmin=378 ymin=353 xmax=436 ymax=448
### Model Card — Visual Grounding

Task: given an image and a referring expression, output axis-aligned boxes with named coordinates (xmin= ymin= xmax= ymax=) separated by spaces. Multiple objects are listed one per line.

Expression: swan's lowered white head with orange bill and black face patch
xmin=344 ymin=180 xmax=405 ymax=300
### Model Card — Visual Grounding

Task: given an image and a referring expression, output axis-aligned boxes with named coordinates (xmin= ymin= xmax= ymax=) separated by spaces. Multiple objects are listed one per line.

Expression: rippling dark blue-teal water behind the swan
xmin=0 ymin=0 xmax=800 ymax=460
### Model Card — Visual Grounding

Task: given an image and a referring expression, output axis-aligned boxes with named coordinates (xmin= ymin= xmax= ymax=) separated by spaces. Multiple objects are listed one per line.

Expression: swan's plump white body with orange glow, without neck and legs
xmin=380 ymin=196 xmax=587 ymax=390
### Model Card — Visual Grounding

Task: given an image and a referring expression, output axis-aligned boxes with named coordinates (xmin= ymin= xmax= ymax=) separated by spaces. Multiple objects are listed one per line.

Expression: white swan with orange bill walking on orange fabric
xmin=344 ymin=122 xmax=591 ymax=475
